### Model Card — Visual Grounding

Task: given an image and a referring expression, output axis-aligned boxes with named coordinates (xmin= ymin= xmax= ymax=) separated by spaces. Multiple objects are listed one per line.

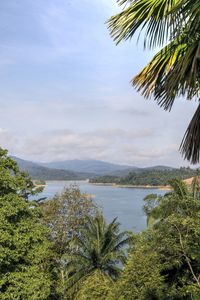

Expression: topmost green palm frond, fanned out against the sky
xmin=108 ymin=0 xmax=180 ymax=48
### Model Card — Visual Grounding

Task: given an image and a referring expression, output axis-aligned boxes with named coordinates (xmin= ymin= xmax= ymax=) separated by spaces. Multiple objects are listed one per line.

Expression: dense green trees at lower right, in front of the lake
xmin=143 ymin=179 xmax=200 ymax=299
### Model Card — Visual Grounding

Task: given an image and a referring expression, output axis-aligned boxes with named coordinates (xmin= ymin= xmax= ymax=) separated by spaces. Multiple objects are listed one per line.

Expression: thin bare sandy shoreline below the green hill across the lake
xmin=90 ymin=182 xmax=171 ymax=191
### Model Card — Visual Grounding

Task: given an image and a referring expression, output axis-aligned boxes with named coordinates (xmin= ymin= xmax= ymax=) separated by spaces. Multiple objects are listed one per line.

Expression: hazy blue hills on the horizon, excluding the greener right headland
xmin=12 ymin=156 xmax=173 ymax=180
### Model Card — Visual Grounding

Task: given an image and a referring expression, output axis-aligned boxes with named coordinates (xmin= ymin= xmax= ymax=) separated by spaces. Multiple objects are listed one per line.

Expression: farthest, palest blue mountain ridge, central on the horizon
xmin=39 ymin=160 xmax=138 ymax=175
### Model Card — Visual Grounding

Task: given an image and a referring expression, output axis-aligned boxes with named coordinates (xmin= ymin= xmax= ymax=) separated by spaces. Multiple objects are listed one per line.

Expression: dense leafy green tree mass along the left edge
xmin=0 ymin=149 xmax=52 ymax=299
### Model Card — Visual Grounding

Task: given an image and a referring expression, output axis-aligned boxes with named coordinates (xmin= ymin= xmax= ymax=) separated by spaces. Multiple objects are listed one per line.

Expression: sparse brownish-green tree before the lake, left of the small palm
xmin=41 ymin=185 xmax=97 ymax=256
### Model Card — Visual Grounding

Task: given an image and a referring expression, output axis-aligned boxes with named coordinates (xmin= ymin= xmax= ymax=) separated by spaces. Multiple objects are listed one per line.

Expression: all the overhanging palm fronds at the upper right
xmin=108 ymin=0 xmax=200 ymax=163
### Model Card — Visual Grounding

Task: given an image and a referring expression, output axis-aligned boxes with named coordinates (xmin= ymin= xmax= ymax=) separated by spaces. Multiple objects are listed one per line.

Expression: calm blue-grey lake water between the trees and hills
xmin=40 ymin=181 xmax=165 ymax=232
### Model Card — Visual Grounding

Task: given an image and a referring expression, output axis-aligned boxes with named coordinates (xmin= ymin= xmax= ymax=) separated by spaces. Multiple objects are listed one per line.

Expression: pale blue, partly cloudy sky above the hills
xmin=0 ymin=0 xmax=197 ymax=167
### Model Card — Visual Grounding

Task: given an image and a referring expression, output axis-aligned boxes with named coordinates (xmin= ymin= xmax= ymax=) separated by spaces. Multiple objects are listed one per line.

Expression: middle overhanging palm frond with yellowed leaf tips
xmin=132 ymin=31 xmax=200 ymax=111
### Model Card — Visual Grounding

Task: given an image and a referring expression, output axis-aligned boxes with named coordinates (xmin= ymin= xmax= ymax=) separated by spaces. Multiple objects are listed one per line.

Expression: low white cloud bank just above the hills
xmin=3 ymin=128 xmax=183 ymax=166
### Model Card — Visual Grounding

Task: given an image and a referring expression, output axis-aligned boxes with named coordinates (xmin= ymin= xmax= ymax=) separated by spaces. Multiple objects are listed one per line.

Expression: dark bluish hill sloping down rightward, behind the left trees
xmin=12 ymin=156 xmax=91 ymax=180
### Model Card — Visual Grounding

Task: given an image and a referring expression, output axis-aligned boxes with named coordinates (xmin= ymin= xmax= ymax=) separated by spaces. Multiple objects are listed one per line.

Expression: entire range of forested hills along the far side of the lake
xmin=12 ymin=157 xmax=196 ymax=186
